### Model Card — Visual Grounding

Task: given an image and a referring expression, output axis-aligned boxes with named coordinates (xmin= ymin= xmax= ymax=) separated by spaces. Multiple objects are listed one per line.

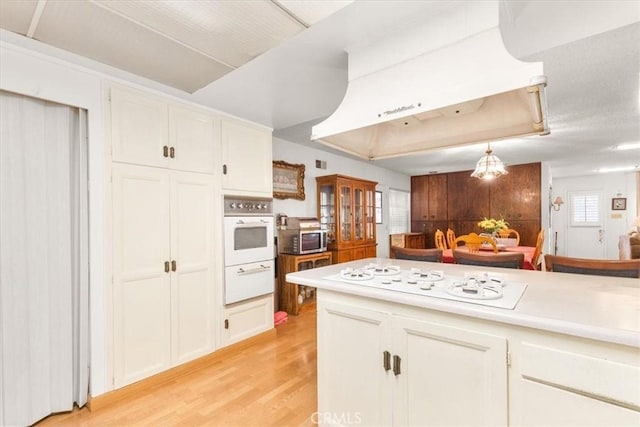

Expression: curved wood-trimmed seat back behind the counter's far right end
xmin=544 ymin=255 xmax=640 ymax=279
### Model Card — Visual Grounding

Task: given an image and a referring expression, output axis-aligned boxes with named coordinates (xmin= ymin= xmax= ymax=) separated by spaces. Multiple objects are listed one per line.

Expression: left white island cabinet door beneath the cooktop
xmin=318 ymin=300 xmax=393 ymax=426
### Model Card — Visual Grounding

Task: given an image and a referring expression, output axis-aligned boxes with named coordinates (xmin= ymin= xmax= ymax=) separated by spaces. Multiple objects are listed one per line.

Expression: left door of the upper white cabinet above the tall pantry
xmin=111 ymin=88 xmax=169 ymax=167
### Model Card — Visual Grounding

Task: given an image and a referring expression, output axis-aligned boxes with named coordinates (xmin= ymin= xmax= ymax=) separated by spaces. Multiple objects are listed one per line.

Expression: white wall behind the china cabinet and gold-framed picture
xmin=273 ymin=138 xmax=411 ymax=257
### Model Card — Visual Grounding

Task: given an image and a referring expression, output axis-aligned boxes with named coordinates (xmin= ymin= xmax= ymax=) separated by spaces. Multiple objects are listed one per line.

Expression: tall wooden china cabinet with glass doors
xmin=316 ymin=175 xmax=377 ymax=263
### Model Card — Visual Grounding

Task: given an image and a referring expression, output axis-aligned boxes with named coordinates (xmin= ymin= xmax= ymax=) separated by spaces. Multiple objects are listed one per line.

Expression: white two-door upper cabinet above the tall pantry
xmin=110 ymin=86 xmax=219 ymax=173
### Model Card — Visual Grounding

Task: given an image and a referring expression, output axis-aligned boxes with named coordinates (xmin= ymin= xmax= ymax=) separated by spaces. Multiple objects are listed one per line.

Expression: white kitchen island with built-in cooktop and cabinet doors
xmin=287 ymin=258 xmax=640 ymax=426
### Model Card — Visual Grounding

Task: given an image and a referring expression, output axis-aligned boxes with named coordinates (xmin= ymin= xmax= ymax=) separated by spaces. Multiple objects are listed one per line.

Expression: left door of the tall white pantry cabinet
xmin=112 ymin=164 xmax=171 ymax=388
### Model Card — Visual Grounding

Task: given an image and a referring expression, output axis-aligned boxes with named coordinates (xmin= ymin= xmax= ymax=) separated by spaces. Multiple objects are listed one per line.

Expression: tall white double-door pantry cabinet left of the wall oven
xmin=112 ymin=163 xmax=217 ymax=388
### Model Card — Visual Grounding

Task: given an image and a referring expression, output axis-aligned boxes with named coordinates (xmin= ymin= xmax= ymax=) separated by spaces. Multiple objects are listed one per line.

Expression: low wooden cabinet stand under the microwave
xmin=278 ymin=252 xmax=331 ymax=315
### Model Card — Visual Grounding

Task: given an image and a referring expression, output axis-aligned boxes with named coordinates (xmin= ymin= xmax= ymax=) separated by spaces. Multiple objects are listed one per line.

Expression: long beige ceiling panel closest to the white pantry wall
xmin=34 ymin=1 xmax=232 ymax=93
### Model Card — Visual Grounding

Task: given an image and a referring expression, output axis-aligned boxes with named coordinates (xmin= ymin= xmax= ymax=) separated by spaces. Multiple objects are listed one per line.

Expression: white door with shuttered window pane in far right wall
xmin=567 ymin=190 xmax=607 ymax=259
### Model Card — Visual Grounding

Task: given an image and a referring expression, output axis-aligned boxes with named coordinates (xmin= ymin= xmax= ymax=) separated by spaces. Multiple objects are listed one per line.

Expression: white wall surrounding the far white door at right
xmin=548 ymin=172 xmax=638 ymax=259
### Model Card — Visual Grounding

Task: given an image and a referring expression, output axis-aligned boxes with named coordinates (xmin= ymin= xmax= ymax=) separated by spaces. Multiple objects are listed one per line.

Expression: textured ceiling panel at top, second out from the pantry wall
xmin=96 ymin=0 xmax=304 ymax=68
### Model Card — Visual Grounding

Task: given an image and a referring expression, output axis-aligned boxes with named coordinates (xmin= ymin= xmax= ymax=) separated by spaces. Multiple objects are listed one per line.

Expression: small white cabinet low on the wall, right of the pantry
xmin=221 ymin=294 xmax=273 ymax=347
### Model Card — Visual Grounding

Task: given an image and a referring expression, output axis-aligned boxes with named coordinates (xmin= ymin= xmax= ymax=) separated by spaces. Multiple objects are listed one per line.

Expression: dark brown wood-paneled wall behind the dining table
xmin=411 ymin=163 xmax=542 ymax=247
